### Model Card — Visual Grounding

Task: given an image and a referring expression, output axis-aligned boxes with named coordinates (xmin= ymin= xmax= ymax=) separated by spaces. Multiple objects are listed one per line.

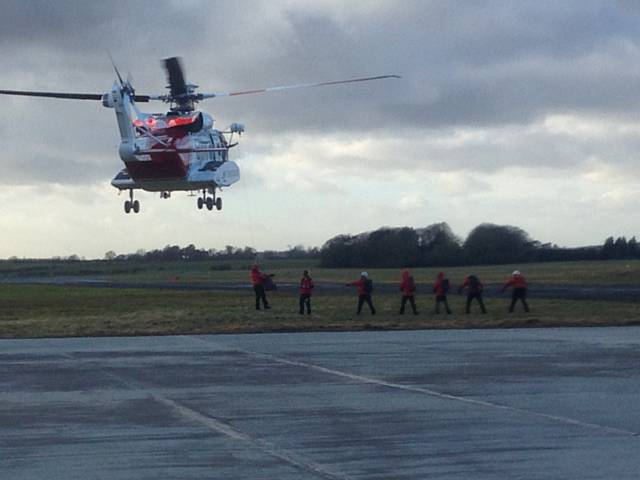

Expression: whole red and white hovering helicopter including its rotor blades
xmin=0 ymin=57 xmax=400 ymax=214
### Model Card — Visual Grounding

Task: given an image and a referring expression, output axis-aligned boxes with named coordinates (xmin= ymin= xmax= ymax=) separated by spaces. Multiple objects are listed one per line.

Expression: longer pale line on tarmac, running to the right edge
xmin=188 ymin=337 xmax=639 ymax=437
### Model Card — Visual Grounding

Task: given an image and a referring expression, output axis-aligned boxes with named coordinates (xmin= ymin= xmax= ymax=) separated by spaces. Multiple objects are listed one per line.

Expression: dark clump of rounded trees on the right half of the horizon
xmin=320 ymin=222 xmax=640 ymax=268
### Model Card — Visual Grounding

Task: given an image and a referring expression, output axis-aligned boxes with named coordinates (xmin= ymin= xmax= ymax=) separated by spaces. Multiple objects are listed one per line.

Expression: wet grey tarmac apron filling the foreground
xmin=0 ymin=327 xmax=640 ymax=480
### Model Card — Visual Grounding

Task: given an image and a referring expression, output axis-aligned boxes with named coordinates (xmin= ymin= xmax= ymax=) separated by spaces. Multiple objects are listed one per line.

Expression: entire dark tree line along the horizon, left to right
xmin=9 ymin=222 xmax=640 ymax=268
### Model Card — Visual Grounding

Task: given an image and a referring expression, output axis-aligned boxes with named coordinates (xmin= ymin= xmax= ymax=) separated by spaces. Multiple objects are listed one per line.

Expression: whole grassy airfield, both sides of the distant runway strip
xmin=0 ymin=261 xmax=640 ymax=338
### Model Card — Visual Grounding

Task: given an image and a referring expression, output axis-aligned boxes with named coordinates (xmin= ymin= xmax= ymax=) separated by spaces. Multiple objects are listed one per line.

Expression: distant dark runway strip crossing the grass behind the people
xmin=0 ymin=277 xmax=640 ymax=302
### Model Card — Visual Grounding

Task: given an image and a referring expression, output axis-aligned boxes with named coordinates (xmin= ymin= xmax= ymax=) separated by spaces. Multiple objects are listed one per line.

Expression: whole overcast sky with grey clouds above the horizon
xmin=0 ymin=0 xmax=640 ymax=258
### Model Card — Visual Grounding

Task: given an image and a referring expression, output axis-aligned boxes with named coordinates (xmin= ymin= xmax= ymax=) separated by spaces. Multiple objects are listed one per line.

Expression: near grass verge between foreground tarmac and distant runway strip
xmin=0 ymin=285 xmax=640 ymax=338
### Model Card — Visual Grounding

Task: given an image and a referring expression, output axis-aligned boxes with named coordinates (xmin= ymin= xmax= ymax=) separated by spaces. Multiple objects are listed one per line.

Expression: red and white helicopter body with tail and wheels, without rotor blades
xmin=103 ymin=85 xmax=244 ymax=213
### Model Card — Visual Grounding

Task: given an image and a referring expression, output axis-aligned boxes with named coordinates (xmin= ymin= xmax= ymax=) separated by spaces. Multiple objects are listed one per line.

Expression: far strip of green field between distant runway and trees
xmin=0 ymin=260 xmax=640 ymax=285
